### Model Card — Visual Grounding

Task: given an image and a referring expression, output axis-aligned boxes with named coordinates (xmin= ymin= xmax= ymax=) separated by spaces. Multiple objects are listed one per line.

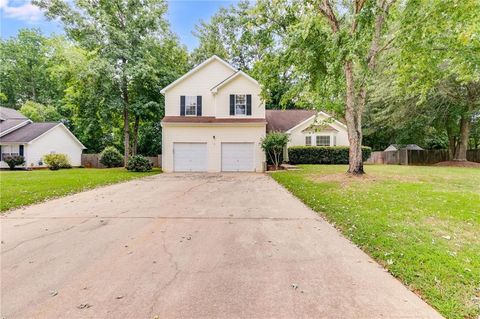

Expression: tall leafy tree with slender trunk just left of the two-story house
xmin=34 ymin=0 xmax=168 ymax=162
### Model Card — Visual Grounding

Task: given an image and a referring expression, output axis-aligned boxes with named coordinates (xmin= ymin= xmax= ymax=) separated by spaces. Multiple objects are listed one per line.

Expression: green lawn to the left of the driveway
xmin=0 ymin=168 xmax=161 ymax=212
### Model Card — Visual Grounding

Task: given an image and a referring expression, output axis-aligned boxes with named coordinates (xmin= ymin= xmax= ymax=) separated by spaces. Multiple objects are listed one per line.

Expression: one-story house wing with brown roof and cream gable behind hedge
xmin=266 ymin=110 xmax=349 ymax=160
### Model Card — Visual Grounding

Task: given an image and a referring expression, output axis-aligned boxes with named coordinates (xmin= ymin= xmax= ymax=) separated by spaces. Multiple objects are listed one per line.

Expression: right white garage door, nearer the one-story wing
xmin=222 ymin=143 xmax=255 ymax=172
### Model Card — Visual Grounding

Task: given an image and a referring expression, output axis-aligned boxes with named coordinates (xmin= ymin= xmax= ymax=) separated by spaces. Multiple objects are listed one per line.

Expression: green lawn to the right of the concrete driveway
xmin=272 ymin=165 xmax=480 ymax=318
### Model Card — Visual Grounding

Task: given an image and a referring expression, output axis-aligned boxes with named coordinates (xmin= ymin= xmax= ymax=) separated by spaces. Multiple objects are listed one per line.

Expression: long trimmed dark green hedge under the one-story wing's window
xmin=288 ymin=146 xmax=372 ymax=164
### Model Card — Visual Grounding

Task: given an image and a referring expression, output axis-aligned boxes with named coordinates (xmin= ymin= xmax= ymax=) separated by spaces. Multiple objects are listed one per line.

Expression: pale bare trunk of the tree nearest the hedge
xmin=344 ymin=61 xmax=365 ymax=175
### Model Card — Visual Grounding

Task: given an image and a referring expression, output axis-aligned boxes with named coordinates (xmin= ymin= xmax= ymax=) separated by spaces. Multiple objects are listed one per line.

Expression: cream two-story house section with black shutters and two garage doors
xmin=161 ymin=56 xmax=266 ymax=172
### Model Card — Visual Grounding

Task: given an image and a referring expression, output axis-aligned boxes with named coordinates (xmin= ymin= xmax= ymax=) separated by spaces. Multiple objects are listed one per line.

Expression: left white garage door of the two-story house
xmin=173 ymin=143 xmax=207 ymax=172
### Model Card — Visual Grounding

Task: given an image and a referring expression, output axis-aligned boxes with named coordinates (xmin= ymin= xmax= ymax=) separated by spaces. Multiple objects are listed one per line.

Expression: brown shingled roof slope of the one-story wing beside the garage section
xmin=265 ymin=110 xmax=317 ymax=132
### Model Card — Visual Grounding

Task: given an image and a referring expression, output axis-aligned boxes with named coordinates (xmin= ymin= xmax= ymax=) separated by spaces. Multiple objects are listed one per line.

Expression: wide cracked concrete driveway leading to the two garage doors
xmin=0 ymin=174 xmax=440 ymax=319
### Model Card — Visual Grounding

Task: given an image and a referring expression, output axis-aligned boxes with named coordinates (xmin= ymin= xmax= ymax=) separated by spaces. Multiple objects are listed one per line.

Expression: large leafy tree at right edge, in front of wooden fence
xmin=397 ymin=0 xmax=480 ymax=161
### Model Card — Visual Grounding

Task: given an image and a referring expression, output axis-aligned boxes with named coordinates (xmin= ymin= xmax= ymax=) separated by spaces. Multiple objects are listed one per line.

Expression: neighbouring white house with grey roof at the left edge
xmin=0 ymin=107 xmax=85 ymax=168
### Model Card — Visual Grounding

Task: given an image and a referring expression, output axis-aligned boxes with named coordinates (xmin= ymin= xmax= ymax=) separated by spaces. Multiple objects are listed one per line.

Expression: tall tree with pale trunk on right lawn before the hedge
xmin=258 ymin=0 xmax=394 ymax=175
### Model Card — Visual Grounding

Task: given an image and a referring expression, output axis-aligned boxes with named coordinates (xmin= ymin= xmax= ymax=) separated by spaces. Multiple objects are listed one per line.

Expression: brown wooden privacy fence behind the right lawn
xmin=365 ymin=150 xmax=480 ymax=165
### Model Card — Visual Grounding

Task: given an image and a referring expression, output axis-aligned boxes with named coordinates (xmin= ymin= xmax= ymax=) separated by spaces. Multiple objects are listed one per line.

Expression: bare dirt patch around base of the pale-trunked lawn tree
xmin=309 ymin=173 xmax=419 ymax=187
